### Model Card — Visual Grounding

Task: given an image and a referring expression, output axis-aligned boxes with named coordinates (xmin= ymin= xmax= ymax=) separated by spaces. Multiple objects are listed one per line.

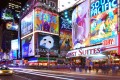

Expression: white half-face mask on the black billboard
xmin=40 ymin=36 xmax=54 ymax=49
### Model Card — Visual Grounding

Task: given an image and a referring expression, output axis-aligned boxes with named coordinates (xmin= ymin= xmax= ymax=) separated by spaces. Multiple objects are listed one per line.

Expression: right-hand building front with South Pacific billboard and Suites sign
xmin=66 ymin=0 xmax=119 ymax=65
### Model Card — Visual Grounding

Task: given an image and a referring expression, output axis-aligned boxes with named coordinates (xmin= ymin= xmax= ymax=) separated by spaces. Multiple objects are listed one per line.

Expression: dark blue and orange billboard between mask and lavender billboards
xmin=59 ymin=17 xmax=72 ymax=51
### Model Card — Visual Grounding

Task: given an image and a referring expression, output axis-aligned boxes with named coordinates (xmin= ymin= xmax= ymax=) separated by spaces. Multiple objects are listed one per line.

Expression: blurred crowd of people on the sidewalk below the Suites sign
xmin=69 ymin=63 xmax=120 ymax=75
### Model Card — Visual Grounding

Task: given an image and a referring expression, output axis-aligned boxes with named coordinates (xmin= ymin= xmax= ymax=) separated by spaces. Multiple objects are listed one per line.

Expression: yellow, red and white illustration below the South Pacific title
xmin=90 ymin=8 xmax=118 ymax=44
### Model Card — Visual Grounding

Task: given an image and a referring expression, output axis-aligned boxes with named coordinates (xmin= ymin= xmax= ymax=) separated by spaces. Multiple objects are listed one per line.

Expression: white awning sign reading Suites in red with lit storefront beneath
xmin=66 ymin=45 xmax=107 ymax=65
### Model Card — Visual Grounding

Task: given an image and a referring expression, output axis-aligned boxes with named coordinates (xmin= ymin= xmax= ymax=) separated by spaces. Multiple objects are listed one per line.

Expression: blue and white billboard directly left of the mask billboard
xmin=22 ymin=35 xmax=34 ymax=57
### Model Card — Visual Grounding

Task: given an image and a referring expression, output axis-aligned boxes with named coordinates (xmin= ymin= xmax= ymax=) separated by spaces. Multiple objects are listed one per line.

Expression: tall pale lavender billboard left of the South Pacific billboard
xmin=72 ymin=0 xmax=90 ymax=49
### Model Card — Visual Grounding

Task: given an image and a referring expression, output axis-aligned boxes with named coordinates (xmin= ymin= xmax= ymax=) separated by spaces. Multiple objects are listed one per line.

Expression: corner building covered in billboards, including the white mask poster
xmin=20 ymin=0 xmax=59 ymax=65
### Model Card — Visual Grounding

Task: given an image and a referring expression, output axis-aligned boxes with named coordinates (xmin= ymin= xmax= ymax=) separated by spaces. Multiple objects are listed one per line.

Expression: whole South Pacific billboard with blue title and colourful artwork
xmin=90 ymin=0 xmax=118 ymax=44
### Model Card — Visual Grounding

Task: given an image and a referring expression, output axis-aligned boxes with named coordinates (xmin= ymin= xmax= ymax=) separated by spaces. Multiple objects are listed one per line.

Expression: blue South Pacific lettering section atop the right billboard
xmin=90 ymin=0 xmax=117 ymax=17
